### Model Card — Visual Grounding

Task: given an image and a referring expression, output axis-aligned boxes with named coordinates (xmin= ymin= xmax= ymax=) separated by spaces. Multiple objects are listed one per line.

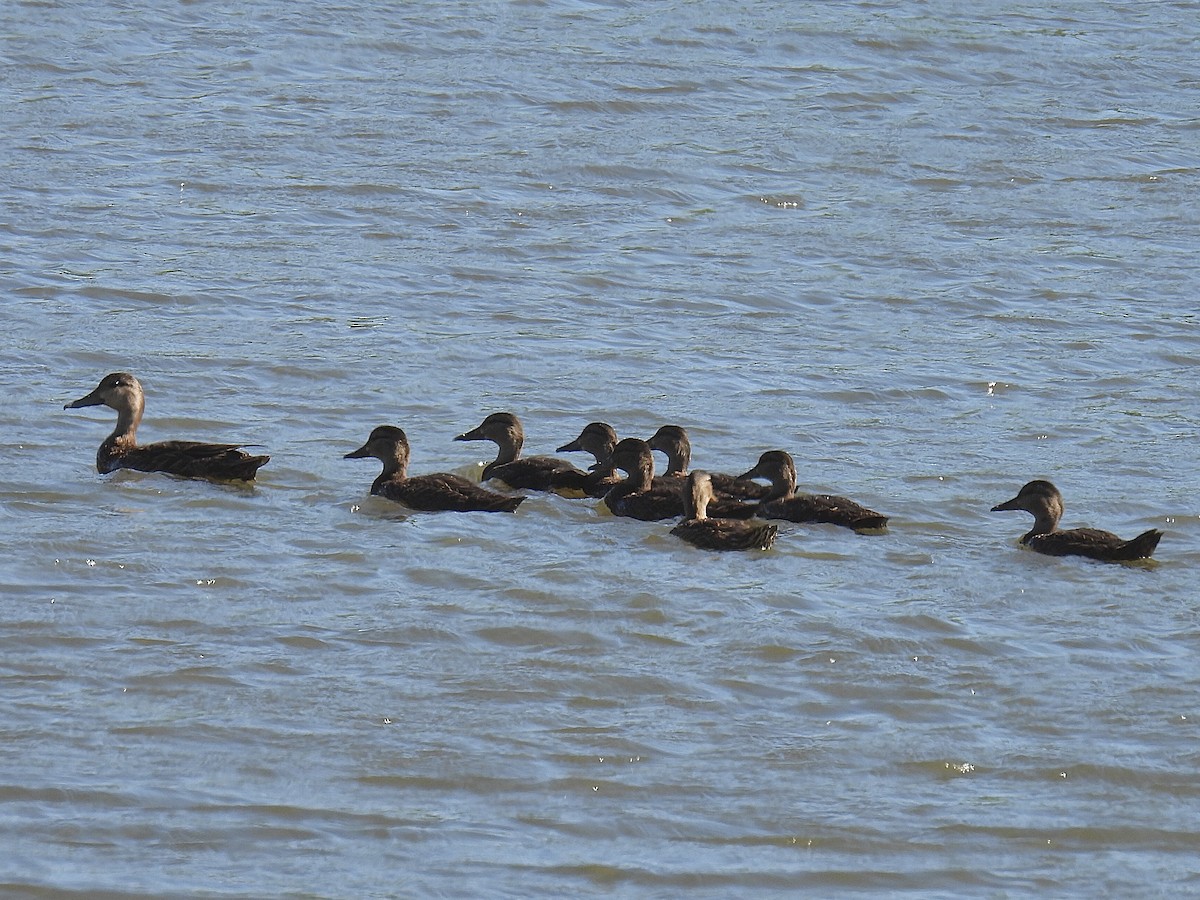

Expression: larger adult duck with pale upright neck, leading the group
xmin=62 ymin=372 xmax=271 ymax=481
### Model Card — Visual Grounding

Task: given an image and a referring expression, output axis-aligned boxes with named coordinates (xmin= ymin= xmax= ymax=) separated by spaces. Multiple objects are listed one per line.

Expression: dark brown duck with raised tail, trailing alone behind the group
xmin=991 ymin=479 xmax=1163 ymax=562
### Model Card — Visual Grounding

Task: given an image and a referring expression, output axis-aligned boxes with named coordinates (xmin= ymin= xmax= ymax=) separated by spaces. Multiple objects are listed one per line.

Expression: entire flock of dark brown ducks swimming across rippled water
xmin=64 ymin=372 xmax=1163 ymax=560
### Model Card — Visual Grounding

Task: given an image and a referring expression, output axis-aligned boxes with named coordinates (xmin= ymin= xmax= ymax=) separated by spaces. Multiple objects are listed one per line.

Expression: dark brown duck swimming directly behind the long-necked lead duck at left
xmin=344 ymin=425 xmax=524 ymax=512
